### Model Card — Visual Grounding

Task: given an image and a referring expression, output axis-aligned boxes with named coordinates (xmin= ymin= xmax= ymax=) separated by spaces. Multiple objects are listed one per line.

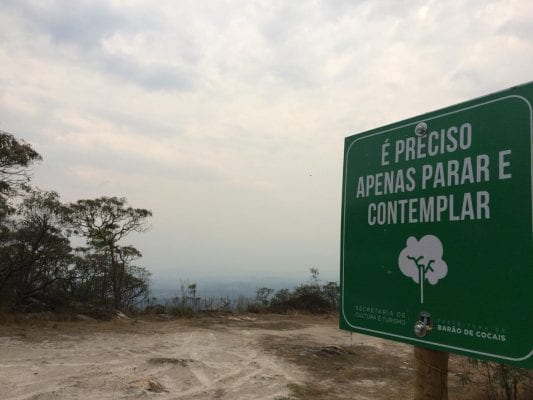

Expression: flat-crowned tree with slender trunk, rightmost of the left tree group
xmin=65 ymin=196 xmax=152 ymax=309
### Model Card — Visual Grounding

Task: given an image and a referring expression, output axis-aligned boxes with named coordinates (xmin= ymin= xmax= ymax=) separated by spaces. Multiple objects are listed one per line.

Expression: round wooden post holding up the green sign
xmin=414 ymin=346 xmax=449 ymax=400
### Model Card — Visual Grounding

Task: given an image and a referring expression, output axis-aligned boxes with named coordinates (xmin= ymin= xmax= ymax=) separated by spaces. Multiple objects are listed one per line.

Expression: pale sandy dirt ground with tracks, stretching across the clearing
xmin=0 ymin=314 xmax=477 ymax=400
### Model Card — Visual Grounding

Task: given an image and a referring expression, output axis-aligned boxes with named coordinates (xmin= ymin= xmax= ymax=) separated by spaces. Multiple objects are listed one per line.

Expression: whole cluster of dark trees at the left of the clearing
xmin=0 ymin=131 xmax=152 ymax=316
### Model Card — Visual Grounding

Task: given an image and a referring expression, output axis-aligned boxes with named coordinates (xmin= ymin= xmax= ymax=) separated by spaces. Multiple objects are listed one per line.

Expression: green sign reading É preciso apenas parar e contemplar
xmin=340 ymin=84 xmax=533 ymax=368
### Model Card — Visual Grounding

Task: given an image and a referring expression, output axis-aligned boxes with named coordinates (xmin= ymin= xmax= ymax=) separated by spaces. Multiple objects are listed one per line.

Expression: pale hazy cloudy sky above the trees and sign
xmin=0 ymin=0 xmax=533 ymax=288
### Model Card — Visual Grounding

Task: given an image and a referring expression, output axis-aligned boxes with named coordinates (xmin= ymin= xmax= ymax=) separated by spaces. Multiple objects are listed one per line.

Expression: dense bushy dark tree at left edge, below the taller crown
xmin=0 ymin=190 xmax=72 ymax=307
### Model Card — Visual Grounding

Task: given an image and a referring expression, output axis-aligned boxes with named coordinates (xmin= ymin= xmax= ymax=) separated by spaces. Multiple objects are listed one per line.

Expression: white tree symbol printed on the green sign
xmin=398 ymin=235 xmax=448 ymax=304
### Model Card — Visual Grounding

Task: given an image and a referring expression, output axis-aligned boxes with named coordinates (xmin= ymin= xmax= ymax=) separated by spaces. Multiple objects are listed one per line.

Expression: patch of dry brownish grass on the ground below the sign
xmin=262 ymin=335 xmax=484 ymax=400
